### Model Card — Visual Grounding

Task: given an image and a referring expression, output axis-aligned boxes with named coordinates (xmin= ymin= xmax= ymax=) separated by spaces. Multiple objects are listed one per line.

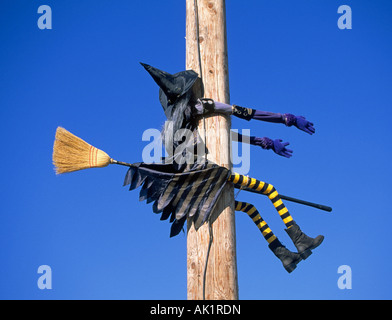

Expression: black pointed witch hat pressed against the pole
xmin=140 ymin=62 xmax=198 ymax=118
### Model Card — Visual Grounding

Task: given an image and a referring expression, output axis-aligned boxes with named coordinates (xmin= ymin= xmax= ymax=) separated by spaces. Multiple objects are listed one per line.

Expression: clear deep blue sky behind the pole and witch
xmin=0 ymin=0 xmax=392 ymax=299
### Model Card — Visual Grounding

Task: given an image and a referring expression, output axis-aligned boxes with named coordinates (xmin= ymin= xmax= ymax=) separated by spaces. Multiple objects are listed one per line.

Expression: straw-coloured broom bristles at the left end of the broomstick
xmin=53 ymin=127 xmax=111 ymax=174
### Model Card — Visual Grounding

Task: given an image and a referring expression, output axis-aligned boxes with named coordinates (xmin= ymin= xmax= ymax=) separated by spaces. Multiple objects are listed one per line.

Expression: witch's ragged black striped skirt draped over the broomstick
xmin=124 ymin=163 xmax=230 ymax=237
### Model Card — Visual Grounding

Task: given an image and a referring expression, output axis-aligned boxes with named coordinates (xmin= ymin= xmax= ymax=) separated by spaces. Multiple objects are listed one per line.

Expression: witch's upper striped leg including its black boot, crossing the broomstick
xmin=229 ymin=173 xmax=324 ymax=260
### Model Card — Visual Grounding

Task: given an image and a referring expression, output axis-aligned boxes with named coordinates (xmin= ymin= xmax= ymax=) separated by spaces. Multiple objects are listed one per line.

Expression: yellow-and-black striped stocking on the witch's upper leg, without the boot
xmin=229 ymin=173 xmax=294 ymax=228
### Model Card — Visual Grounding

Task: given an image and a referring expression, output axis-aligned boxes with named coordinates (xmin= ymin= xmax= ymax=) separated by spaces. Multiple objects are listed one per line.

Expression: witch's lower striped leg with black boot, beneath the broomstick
xmin=235 ymin=201 xmax=302 ymax=273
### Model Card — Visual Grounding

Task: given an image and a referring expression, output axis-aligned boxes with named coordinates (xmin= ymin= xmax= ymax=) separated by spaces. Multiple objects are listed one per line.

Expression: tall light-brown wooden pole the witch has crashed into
xmin=186 ymin=0 xmax=238 ymax=300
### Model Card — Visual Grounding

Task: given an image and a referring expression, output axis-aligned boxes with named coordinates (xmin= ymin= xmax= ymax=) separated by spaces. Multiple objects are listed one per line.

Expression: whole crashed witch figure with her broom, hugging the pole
xmin=53 ymin=63 xmax=332 ymax=273
